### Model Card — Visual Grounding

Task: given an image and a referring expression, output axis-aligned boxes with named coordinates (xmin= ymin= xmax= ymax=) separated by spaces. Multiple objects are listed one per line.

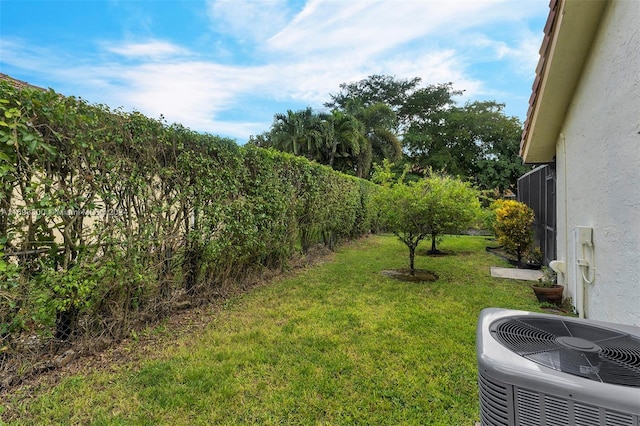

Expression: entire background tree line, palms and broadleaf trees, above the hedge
xmin=251 ymin=75 xmax=530 ymax=191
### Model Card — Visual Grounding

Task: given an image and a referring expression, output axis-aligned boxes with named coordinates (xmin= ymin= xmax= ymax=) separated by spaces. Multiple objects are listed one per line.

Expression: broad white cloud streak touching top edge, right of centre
xmin=268 ymin=0 xmax=524 ymax=54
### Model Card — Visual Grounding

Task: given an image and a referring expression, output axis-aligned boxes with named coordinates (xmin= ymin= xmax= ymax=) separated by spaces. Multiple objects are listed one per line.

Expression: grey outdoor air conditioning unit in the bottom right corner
xmin=476 ymin=308 xmax=640 ymax=426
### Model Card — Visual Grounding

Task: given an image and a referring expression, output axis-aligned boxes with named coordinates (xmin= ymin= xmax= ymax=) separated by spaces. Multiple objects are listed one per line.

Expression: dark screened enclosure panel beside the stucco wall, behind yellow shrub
xmin=518 ymin=163 xmax=557 ymax=265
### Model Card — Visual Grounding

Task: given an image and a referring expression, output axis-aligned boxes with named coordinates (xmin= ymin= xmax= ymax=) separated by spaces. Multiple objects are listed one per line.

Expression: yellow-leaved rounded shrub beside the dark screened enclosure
xmin=493 ymin=200 xmax=535 ymax=263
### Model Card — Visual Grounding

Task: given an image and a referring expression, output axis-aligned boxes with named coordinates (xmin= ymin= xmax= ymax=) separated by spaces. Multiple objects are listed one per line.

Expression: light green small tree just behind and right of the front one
xmin=423 ymin=173 xmax=480 ymax=254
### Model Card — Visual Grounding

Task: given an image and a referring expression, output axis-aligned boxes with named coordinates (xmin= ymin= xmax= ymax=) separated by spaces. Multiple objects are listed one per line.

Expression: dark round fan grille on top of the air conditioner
xmin=490 ymin=316 xmax=640 ymax=386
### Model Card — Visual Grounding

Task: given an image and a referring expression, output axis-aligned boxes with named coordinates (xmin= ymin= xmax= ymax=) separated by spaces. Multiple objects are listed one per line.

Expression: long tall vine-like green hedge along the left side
xmin=0 ymin=81 xmax=377 ymax=370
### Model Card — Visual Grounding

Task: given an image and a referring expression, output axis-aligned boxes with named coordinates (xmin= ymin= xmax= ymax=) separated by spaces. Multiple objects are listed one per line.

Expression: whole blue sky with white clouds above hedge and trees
xmin=0 ymin=0 xmax=549 ymax=144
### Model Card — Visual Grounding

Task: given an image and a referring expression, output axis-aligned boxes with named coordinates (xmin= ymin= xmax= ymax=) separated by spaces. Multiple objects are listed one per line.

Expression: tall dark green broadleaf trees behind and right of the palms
xmin=325 ymin=75 xmax=531 ymax=192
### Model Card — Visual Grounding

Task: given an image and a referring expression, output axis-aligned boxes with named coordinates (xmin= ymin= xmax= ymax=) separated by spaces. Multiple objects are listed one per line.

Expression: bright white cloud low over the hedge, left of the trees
xmin=58 ymin=61 xmax=270 ymax=140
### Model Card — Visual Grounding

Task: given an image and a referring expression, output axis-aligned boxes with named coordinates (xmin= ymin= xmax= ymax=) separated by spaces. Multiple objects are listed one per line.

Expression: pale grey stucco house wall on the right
xmin=556 ymin=0 xmax=640 ymax=326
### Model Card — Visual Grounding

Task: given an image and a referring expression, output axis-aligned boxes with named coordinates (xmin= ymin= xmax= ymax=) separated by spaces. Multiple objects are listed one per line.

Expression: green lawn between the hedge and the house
xmin=0 ymin=236 xmax=539 ymax=425
